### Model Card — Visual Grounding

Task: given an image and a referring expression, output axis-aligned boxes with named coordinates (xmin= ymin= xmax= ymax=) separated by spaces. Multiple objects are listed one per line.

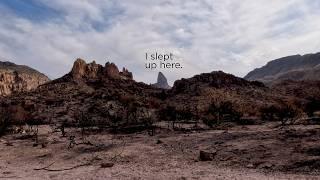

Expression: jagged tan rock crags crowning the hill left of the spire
xmin=69 ymin=59 xmax=133 ymax=80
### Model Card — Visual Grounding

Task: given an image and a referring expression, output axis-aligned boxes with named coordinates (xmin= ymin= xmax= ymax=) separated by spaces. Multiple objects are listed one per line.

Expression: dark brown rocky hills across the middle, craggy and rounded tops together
xmin=0 ymin=59 xmax=320 ymax=127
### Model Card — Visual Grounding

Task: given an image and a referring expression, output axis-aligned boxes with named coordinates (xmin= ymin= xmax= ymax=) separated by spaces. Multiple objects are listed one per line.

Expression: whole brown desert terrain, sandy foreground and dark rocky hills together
xmin=0 ymin=56 xmax=320 ymax=179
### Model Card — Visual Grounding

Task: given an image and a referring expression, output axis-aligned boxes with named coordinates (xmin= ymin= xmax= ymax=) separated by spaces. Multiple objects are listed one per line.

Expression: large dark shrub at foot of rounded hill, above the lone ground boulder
xmin=204 ymin=101 xmax=242 ymax=126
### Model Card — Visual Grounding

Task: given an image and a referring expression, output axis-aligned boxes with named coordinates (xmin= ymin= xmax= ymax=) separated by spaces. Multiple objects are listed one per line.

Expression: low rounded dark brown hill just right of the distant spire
xmin=167 ymin=71 xmax=286 ymax=116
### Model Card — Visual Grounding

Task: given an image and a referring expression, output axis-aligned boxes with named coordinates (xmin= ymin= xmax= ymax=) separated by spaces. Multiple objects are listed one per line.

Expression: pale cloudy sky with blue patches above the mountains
xmin=0 ymin=0 xmax=320 ymax=85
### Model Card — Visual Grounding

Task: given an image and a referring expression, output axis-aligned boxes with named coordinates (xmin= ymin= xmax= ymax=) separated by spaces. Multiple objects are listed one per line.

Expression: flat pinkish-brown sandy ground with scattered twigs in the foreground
xmin=0 ymin=125 xmax=320 ymax=180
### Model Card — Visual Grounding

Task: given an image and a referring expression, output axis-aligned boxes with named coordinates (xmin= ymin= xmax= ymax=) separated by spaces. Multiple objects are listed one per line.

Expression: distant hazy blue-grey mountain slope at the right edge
xmin=244 ymin=53 xmax=320 ymax=83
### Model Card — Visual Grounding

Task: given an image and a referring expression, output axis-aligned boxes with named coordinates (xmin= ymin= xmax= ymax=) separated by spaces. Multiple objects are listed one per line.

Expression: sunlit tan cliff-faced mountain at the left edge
xmin=0 ymin=61 xmax=49 ymax=96
